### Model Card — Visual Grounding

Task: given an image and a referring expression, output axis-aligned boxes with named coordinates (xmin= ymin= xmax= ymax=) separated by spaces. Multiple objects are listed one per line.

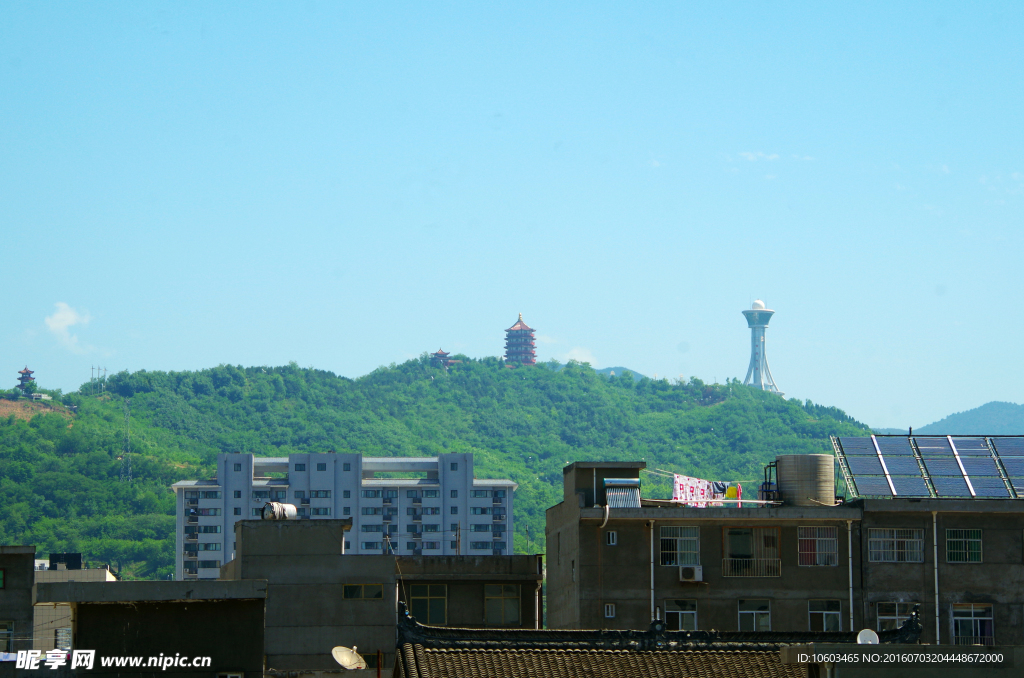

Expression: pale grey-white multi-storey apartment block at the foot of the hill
xmin=171 ymin=452 xmax=518 ymax=580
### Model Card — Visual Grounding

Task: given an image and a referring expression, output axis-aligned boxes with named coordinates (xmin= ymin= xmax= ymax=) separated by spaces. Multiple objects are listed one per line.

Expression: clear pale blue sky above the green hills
xmin=0 ymin=2 xmax=1024 ymax=426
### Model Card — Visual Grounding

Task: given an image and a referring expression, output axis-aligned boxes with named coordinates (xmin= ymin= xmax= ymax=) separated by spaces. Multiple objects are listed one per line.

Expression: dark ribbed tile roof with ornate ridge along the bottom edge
xmin=394 ymin=643 xmax=807 ymax=678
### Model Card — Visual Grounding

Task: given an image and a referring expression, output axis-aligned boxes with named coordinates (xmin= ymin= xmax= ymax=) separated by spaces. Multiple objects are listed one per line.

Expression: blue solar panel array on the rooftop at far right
xmin=833 ymin=435 xmax=1024 ymax=499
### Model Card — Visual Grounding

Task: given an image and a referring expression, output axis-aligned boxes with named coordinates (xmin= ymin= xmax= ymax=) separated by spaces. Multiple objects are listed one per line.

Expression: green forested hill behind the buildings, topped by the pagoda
xmin=0 ymin=356 xmax=866 ymax=577
